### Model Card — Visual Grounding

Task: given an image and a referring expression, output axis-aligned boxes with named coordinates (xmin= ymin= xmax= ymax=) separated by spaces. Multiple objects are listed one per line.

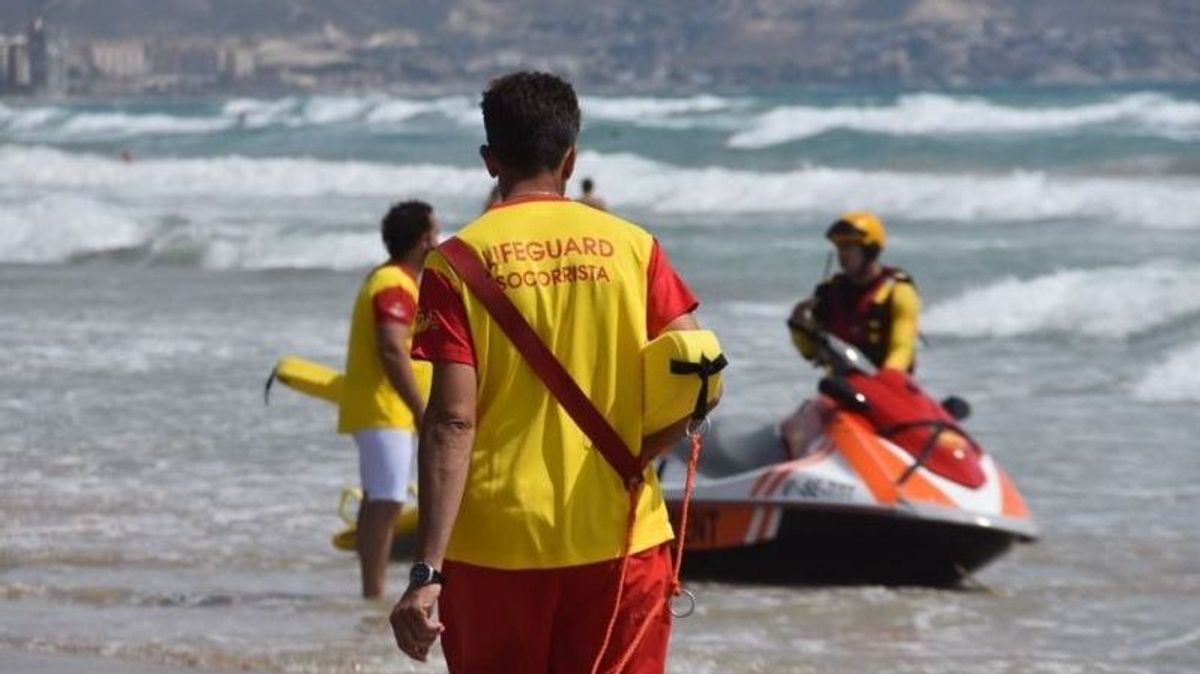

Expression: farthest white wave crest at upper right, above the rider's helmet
xmin=728 ymin=92 xmax=1200 ymax=149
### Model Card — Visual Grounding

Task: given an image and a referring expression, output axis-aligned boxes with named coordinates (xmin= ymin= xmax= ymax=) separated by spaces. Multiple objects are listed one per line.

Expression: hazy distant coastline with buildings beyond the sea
xmin=0 ymin=0 xmax=1200 ymax=97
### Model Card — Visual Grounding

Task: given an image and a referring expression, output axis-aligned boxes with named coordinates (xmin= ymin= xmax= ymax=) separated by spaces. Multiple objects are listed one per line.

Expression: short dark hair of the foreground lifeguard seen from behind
xmin=480 ymin=72 xmax=580 ymax=177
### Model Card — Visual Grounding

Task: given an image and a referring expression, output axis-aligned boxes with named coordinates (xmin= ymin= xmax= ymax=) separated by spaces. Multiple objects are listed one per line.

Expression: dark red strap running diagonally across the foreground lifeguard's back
xmin=438 ymin=236 xmax=646 ymax=487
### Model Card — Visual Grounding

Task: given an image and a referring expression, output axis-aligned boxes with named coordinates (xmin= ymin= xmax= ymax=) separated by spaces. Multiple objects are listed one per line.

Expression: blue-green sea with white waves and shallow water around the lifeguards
xmin=0 ymin=88 xmax=1200 ymax=674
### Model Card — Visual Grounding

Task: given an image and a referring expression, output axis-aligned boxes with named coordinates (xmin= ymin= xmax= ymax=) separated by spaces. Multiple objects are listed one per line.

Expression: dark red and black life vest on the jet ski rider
xmin=815 ymin=266 xmax=916 ymax=372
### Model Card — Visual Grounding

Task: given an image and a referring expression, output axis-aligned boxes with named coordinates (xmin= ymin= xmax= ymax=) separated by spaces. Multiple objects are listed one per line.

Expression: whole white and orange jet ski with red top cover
xmin=659 ymin=333 xmax=1038 ymax=586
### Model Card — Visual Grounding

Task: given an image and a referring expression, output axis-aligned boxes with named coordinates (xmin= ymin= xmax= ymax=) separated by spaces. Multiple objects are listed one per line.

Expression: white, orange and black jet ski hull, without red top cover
xmin=660 ymin=395 xmax=1037 ymax=586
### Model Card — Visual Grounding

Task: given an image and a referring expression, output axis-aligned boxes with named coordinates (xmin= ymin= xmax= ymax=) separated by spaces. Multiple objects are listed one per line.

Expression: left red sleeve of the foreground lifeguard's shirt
xmin=413 ymin=269 xmax=475 ymax=366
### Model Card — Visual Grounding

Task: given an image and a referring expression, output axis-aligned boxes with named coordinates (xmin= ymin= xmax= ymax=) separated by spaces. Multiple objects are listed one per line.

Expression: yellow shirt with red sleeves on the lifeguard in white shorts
xmin=337 ymin=261 xmax=418 ymax=433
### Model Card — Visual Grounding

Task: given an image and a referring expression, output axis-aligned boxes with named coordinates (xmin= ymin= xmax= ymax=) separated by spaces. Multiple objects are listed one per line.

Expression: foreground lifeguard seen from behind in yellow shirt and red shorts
xmin=391 ymin=72 xmax=697 ymax=674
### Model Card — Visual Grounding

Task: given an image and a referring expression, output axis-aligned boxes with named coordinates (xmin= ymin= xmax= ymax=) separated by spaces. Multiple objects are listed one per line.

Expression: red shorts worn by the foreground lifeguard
xmin=438 ymin=543 xmax=672 ymax=674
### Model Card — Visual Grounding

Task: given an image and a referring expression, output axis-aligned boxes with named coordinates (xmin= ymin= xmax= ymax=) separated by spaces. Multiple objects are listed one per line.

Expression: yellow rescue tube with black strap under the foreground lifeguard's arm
xmin=642 ymin=330 xmax=725 ymax=435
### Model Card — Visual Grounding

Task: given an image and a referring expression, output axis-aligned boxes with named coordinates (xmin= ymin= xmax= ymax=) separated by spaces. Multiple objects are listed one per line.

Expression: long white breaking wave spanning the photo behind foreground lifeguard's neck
xmin=7 ymin=146 xmax=1200 ymax=229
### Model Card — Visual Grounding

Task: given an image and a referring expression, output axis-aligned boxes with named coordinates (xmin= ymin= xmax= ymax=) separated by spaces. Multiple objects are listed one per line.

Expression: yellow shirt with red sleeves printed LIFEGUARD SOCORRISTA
xmin=413 ymin=197 xmax=697 ymax=568
